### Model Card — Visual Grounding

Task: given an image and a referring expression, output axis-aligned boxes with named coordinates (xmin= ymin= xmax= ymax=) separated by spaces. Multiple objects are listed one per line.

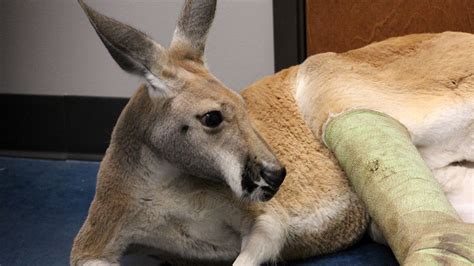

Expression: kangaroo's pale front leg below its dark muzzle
xmin=233 ymin=213 xmax=287 ymax=266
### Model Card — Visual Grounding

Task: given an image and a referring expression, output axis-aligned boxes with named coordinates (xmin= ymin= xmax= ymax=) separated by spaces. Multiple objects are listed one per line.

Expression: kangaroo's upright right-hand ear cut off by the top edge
xmin=171 ymin=0 xmax=217 ymax=60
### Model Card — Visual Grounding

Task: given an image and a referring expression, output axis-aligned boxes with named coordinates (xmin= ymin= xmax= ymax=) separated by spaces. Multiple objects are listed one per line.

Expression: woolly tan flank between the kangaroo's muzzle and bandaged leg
xmin=242 ymin=67 xmax=367 ymax=258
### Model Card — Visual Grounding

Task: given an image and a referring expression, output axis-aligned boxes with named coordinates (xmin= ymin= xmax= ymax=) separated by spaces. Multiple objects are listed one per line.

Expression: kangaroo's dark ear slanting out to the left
xmin=78 ymin=0 xmax=167 ymax=95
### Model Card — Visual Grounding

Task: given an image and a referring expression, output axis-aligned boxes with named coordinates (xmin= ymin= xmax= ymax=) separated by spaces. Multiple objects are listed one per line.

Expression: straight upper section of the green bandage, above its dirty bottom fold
xmin=324 ymin=110 xmax=459 ymax=262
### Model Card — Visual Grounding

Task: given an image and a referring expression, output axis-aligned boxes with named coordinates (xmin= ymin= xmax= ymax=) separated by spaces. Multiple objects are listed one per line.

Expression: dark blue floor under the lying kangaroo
xmin=0 ymin=157 xmax=397 ymax=266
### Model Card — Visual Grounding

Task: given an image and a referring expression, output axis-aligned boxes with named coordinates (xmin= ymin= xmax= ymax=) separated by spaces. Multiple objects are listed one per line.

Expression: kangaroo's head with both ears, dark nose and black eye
xmin=79 ymin=0 xmax=286 ymax=201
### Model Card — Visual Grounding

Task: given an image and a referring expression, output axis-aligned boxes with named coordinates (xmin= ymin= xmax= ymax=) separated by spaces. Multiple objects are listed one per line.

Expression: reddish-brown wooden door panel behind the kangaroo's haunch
xmin=306 ymin=0 xmax=474 ymax=56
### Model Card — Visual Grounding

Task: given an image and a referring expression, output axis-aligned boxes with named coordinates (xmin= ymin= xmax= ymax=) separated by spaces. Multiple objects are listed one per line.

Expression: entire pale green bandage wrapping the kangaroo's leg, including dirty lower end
xmin=323 ymin=110 xmax=474 ymax=265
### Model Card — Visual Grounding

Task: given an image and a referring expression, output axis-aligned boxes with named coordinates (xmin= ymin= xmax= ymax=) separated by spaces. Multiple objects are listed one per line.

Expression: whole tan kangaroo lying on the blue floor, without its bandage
xmin=71 ymin=0 xmax=474 ymax=265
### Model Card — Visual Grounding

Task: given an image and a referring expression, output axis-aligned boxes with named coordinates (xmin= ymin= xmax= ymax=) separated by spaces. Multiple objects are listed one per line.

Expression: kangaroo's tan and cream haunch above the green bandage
xmin=295 ymin=32 xmax=474 ymax=139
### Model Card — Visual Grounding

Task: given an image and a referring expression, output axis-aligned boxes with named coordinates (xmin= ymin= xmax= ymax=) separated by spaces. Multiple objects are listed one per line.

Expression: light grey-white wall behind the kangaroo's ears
xmin=0 ymin=0 xmax=274 ymax=97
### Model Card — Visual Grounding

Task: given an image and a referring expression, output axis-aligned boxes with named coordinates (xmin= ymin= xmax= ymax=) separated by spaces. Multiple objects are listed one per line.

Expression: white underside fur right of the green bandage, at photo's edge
xmin=413 ymin=102 xmax=474 ymax=223
